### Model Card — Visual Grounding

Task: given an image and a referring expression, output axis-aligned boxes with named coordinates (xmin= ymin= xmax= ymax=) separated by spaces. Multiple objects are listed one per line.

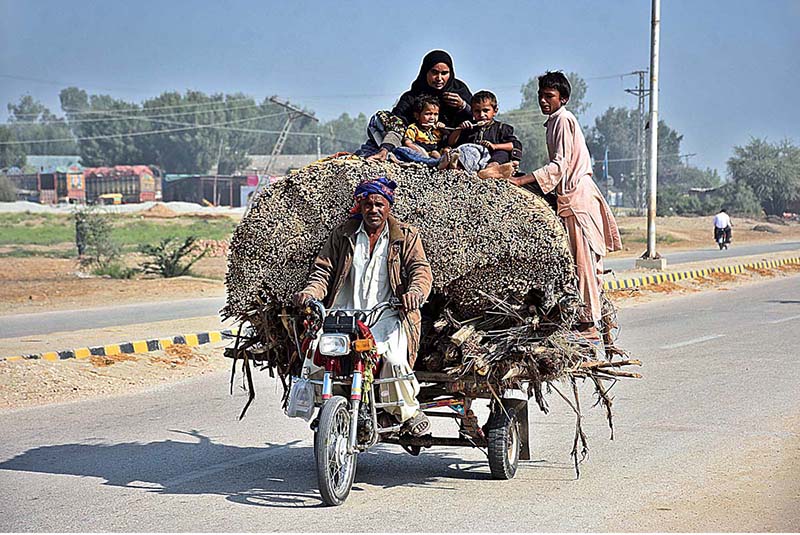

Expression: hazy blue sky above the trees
xmin=0 ymin=0 xmax=800 ymax=175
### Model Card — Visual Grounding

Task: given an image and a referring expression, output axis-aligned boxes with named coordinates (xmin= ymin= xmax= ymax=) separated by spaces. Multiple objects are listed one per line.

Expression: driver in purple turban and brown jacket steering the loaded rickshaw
xmin=293 ymin=177 xmax=433 ymax=436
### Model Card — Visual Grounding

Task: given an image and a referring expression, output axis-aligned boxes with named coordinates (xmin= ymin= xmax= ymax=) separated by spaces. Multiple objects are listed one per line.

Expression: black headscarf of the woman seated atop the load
xmin=392 ymin=50 xmax=472 ymax=126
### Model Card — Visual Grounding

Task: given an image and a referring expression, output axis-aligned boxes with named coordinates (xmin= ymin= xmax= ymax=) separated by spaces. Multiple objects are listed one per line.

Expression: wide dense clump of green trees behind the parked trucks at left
xmin=61 ymin=87 xmax=276 ymax=174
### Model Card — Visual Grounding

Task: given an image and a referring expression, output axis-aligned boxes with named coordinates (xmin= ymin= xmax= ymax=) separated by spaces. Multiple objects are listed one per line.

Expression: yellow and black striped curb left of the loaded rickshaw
xmin=0 ymin=329 xmax=236 ymax=361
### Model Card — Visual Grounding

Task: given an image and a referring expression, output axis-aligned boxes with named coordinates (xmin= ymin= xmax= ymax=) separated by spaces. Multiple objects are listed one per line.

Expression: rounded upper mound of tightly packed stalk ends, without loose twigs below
xmin=224 ymin=160 xmax=574 ymax=317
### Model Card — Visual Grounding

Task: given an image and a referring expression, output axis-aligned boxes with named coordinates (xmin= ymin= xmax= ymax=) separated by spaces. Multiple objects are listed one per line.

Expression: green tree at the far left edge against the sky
xmin=8 ymin=95 xmax=78 ymax=155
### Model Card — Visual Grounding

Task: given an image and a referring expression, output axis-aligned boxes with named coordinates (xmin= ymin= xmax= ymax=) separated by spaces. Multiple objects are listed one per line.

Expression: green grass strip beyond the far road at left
xmin=0 ymin=213 xmax=236 ymax=251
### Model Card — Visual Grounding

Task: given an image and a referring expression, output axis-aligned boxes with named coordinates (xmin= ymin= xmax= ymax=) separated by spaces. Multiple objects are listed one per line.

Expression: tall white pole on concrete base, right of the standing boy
xmin=636 ymin=0 xmax=667 ymax=269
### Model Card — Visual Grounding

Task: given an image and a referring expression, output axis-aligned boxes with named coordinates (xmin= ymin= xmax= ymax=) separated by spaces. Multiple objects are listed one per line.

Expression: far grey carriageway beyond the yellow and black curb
xmin=0 ymin=242 xmax=800 ymax=338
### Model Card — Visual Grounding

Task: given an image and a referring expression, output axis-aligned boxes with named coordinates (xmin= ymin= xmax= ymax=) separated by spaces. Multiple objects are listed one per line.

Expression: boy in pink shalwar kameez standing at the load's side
xmin=511 ymin=72 xmax=622 ymax=340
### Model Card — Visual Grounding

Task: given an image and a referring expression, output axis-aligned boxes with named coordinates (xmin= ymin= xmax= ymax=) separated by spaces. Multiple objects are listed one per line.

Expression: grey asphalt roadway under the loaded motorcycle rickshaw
xmin=0 ymin=276 xmax=800 ymax=532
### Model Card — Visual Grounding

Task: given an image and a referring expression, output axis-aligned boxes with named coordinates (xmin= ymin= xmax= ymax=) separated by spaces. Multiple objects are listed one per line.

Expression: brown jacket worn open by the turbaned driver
xmin=303 ymin=215 xmax=433 ymax=367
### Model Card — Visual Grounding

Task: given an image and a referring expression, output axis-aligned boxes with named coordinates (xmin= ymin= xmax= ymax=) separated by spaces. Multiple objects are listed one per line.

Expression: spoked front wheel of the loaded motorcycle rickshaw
xmin=314 ymin=396 xmax=358 ymax=505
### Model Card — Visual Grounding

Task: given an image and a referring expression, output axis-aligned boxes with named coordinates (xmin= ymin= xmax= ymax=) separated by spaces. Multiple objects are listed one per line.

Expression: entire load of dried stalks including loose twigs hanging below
xmin=223 ymin=159 xmax=637 ymax=472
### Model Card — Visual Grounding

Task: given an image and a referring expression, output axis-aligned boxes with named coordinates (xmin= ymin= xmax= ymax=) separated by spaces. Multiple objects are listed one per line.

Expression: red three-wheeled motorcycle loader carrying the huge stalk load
xmin=287 ymin=301 xmax=530 ymax=505
